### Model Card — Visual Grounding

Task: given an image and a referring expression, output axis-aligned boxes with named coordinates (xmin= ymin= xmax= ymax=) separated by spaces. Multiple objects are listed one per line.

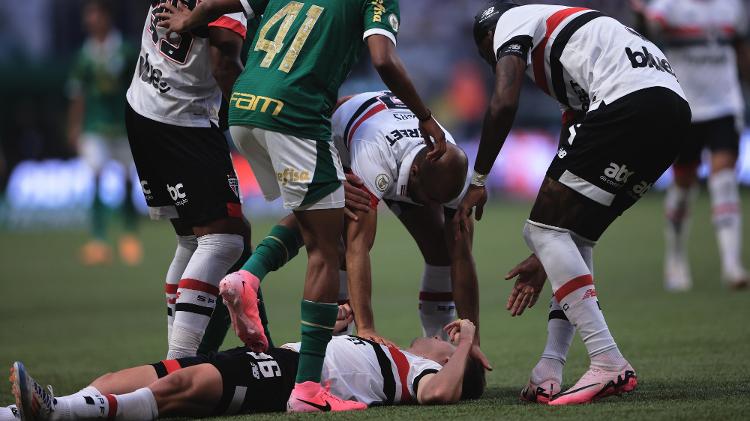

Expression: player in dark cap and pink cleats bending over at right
xmin=458 ymin=1 xmax=690 ymax=405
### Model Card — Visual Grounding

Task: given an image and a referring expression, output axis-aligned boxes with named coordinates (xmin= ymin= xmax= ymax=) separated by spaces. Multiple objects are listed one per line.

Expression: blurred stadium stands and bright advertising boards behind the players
xmin=0 ymin=0 xmax=750 ymax=229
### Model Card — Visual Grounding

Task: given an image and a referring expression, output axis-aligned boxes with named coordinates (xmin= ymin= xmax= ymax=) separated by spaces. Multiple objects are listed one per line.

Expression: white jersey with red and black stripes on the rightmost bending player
xmin=494 ymin=5 xmax=684 ymax=115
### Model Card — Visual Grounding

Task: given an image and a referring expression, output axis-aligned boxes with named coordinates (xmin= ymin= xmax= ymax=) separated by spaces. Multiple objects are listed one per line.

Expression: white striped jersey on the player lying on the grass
xmin=283 ymin=335 xmax=442 ymax=405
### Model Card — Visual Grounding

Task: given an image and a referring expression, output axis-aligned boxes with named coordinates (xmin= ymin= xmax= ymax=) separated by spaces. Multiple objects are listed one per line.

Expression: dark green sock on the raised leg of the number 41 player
xmin=242 ymin=225 xmax=303 ymax=281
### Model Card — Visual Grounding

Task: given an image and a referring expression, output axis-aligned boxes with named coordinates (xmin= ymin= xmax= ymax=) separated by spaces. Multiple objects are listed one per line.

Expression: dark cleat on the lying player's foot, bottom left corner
xmin=10 ymin=361 xmax=56 ymax=421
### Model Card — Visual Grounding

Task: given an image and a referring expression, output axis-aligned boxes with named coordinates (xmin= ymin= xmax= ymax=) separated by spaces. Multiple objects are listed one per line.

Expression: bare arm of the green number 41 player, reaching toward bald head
xmin=367 ymin=34 xmax=447 ymax=159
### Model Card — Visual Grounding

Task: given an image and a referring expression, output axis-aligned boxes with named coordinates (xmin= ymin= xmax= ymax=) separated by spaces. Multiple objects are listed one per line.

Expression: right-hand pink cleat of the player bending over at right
xmin=549 ymin=364 xmax=638 ymax=405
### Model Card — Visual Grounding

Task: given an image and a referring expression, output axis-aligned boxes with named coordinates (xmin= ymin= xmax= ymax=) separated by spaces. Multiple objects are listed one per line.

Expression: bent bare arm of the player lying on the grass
xmin=419 ymin=340 xmax=472 ymax=404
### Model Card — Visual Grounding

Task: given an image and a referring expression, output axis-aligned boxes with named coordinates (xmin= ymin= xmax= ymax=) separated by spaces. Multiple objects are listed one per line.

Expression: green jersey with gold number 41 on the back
xmin=229 ymin=0 xmax=400 ymax=140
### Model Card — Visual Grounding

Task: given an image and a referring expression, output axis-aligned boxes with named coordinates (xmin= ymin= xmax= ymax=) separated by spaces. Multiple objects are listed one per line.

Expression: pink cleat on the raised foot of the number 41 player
xmin=219 ymin=270 xmax=268 ymax=352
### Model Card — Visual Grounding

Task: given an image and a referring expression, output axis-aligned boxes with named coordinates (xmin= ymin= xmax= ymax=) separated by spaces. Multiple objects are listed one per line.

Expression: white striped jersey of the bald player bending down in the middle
xmin=331 ymin=91 xmax=468 ymax=208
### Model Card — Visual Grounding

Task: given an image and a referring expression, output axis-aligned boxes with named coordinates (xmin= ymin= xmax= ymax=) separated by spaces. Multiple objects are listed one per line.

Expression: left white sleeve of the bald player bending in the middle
xmin=351 ymin=139 xmax=396 ymax=209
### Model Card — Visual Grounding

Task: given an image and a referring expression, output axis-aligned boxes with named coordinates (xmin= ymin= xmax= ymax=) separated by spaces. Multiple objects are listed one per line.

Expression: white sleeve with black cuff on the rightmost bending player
xmin=493 ymin=7 xmax=543 ymax=63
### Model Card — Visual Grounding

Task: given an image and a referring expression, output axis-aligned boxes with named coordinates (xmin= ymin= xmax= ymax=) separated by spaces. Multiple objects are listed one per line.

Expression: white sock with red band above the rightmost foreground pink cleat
xmin=524 ymin=223 xmax=626 ymax=370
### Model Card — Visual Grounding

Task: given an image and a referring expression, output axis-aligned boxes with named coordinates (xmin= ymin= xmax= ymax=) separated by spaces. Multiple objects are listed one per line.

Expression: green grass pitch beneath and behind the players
xmin=0 ymin=194 xmax=750 ymax=420
